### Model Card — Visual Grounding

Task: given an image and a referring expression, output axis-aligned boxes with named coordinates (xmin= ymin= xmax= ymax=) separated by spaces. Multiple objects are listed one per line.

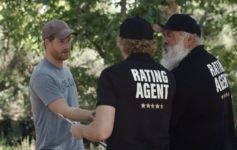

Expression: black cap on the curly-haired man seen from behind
xmin=119 ymin=16 xmax=153 ymax=40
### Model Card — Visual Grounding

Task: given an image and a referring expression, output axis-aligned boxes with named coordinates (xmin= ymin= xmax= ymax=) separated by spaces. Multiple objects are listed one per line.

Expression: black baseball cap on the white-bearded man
xmin=159 ymin=14 xmax=201 ymax=37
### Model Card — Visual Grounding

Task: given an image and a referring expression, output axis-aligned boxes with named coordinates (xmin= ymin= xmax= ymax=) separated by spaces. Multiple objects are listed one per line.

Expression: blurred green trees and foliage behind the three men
xmin=0 ymin=0 xmax=237 ymax=148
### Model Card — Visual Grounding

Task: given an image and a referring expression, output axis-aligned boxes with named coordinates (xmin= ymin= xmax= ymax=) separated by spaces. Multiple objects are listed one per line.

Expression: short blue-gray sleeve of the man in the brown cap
xmin=30 ymin=74 xmax=64 ymax=106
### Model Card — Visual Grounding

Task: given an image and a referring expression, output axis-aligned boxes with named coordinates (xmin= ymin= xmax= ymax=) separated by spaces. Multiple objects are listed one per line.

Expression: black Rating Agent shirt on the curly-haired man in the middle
xmin=97 ymin=53 xmax=175 ymax=150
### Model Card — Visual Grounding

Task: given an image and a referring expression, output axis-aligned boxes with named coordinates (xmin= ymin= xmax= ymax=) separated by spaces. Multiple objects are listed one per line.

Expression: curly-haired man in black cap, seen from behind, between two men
xmin=71 ymin=16 xmax=175 ymax=150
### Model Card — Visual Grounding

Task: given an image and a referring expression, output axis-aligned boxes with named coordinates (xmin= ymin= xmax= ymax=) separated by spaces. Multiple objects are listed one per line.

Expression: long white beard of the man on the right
xmin=160 ymin=39 xmax=191 ymax=70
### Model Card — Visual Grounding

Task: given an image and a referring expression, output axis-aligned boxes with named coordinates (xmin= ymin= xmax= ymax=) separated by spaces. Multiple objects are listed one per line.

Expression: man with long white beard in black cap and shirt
xmin=153 ymin=14 xmax=236 ymax=150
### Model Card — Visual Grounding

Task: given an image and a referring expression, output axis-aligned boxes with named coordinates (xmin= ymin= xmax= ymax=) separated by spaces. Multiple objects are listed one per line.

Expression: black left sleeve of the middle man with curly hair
xmin=97 ymin=70 xmax=116 ymax=107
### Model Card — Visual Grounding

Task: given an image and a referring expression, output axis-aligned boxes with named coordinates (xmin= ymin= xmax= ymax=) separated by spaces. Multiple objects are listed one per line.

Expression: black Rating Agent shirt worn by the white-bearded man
xmin=170 ymin=46 xmax=234 ymax=150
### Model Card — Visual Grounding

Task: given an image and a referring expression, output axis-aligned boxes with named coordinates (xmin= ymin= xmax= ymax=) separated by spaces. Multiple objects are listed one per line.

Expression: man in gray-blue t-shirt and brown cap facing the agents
xmin=29 ymin=20 xmax=92 ymax=150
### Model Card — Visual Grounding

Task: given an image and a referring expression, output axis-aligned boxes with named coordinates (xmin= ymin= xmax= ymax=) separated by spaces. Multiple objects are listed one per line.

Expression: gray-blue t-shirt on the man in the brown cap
xmin=29 ymin=59 xmax=83 ymax=150
